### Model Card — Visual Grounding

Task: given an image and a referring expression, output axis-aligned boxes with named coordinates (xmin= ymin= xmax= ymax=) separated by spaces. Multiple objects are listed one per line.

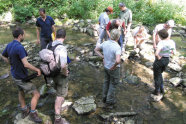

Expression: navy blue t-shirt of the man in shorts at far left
xmin=2 ymin=40 xmax=28 ymax=79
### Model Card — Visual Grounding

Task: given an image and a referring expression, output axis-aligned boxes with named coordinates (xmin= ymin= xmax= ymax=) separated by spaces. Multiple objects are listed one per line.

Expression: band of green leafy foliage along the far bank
xmin=0 ymin=0 xmax=186 ymax=25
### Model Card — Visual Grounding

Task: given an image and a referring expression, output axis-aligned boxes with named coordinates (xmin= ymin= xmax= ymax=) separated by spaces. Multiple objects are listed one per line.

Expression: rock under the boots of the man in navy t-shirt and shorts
xmin=14 ymin=113 xmax=52 ymax=124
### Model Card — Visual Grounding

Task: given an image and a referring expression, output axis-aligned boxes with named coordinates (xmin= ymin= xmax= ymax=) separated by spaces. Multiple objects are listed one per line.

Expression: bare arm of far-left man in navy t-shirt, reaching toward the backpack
xmin=21 ymin=57 xmax=41 ymax=76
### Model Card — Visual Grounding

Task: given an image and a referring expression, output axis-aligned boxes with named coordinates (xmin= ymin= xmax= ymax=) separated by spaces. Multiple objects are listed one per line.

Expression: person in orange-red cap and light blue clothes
xmin=96 ymin=6 xmax=113 ymax=46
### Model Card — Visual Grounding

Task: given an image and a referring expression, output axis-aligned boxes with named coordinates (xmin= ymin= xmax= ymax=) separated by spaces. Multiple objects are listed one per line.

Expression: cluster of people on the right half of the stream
xmin=94 ymin=3 xmax=176 ymax=108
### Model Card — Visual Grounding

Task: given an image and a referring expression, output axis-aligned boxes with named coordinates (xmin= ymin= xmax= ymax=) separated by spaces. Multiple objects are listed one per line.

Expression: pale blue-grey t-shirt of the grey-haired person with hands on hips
xmin=99 ymin=40 xmax=121 ymax=69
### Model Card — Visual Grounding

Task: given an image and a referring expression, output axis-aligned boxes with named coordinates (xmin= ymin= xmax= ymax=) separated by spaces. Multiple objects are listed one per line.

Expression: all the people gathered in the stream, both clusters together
xmin=2 ymin=3 xmax=175 ymax=124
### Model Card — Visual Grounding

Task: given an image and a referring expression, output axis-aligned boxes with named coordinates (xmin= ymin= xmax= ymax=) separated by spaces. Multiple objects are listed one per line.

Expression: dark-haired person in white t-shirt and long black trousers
xmin=151 ymin=29 xmax=176 ymax=101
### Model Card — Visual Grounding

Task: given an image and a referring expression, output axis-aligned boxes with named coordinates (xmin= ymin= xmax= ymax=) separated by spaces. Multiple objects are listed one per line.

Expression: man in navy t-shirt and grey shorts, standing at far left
xmin=1 ymin=28 xmax=42 ymax=123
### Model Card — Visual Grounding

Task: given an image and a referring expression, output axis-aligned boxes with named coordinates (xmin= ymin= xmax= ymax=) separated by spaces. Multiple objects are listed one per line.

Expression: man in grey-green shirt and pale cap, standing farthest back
xmin=119 ymin=3 xmax=132 ymax=51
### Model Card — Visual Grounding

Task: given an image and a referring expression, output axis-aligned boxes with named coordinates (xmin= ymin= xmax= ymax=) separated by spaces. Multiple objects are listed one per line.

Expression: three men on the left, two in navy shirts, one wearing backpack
xmin=2 ymin=8 xmax=69 ymax=124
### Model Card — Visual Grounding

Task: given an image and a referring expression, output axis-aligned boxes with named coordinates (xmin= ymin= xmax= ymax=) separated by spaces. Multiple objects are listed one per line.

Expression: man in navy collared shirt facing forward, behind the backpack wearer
xmin=36 ymin=8 xmax=55 ymax=49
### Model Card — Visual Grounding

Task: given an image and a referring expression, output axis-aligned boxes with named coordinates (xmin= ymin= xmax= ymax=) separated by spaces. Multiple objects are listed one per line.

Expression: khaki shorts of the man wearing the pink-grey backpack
xmin=53 ymin=74 xmax=68 ymax=97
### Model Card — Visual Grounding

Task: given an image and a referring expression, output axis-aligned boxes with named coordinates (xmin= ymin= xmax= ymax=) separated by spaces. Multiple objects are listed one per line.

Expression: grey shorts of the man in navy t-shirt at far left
xmin=12 ymin=78 xmax=37 ymax=93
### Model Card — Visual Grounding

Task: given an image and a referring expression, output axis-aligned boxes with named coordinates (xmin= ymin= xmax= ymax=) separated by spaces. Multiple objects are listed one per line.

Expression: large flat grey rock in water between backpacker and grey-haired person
xmin=72 ymin=96 xmax=96 ymax=114
